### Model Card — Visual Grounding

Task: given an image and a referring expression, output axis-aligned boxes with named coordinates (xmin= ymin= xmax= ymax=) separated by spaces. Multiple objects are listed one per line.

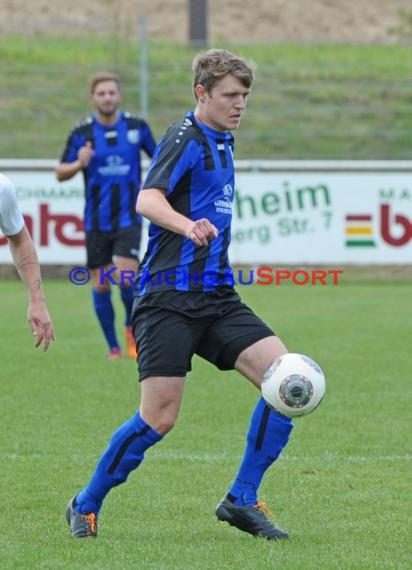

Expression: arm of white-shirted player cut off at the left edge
xmin=0 ymin=174 xmax=55 ymax=351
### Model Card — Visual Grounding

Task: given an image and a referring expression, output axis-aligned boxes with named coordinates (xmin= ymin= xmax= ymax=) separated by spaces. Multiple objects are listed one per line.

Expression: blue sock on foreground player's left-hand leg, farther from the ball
xmin=75 ymin=413 xmax=163 ymax=514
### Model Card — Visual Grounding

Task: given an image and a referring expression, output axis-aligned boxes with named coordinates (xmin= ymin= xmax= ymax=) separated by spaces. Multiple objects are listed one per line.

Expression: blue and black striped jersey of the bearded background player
xmin=61 ymin=111 xmax=156 ymax=231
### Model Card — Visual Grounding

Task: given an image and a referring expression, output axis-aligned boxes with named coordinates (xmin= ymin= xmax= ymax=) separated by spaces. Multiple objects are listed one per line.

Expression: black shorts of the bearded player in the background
xmin=86 ymin=224 xmax=142 ymax=269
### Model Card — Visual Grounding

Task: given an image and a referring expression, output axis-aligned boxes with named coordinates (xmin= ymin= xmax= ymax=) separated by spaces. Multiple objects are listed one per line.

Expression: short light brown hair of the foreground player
xmin=192 ymin=49 xmax=256 ymax=96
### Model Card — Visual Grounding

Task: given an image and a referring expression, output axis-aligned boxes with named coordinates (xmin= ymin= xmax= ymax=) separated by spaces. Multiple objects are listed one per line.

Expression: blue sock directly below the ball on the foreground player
xmin=228 ymin=398 xmax=293 ymax=505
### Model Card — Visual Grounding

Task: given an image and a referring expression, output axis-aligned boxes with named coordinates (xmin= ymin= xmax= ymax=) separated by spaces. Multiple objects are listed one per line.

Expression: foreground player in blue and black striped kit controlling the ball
xmin=66 ymin=49 xmax=292 ymax=539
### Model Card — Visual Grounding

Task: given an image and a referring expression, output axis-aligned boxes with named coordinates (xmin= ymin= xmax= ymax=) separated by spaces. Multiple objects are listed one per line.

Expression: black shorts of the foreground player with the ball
xmin=133 ymin=287 xmax=275 ymax=380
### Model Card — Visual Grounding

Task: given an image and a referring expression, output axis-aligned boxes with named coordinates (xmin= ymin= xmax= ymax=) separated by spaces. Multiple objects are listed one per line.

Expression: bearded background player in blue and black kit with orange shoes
xmin=56 ymin=73 xmax=156 ymax=359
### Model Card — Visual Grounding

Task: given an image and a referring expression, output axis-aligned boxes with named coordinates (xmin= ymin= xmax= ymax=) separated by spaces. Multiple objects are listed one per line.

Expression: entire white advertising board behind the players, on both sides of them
xmin=0 ymin=161 xmax=412 ymax=265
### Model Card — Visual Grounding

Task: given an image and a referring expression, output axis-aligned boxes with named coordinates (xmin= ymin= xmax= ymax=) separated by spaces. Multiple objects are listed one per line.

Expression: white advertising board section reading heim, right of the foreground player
xmin=231 ymin=172 xmax=412 ymax=264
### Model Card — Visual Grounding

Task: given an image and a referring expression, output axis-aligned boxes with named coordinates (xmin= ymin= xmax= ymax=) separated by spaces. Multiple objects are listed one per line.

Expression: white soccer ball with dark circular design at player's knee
xmin=261 ymin=353 xmax=325 ymax=418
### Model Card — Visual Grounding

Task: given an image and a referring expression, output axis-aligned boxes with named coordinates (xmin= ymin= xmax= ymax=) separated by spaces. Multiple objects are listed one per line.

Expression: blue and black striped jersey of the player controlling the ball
xmin=136 ymin=113 xmax=235 ymax=296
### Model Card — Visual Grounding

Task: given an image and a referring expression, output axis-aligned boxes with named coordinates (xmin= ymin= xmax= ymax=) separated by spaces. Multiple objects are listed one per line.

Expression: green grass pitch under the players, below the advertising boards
xmin=0 ymin=272 xmax=412 ymax=570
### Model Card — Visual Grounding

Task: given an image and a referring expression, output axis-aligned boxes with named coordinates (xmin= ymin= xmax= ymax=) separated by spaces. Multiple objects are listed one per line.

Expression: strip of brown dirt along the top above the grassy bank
xmin=0 ymin=0 xmax=412 ymax=45
